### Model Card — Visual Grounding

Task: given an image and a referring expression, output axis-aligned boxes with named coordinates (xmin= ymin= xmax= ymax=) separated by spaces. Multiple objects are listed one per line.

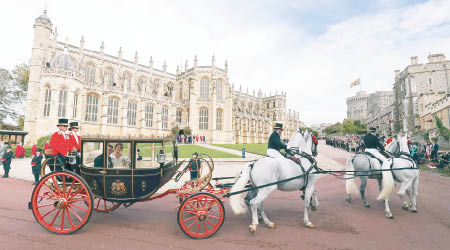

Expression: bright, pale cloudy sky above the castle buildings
xmin=0 ymin=0 xmax=450 ymax=125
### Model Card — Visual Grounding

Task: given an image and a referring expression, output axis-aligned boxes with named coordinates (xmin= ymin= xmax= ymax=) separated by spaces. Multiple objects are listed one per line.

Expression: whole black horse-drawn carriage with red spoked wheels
xmin=29 ymin=138 xmax=225 ymax=238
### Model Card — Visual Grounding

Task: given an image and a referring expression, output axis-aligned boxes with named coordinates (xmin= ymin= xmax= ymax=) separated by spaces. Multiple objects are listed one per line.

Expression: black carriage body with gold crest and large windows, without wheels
xmin=80 ymin=139 xmax=182 ymax=203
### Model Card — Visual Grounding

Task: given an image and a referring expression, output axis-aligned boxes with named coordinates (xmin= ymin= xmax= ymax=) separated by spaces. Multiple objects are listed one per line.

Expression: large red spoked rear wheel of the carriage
xmin=31 ymin=172 xmax=93 ymax=234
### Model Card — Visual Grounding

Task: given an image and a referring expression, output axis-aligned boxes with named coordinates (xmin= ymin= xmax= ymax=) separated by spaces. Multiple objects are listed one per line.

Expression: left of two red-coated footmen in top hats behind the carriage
xmin=50 ymin=119 xmax=71 ymax=169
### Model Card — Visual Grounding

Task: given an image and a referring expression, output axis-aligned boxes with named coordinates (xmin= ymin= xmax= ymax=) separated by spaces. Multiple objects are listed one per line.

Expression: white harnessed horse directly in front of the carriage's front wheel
xmin=230 ymin=132 xmax=319 ymax=233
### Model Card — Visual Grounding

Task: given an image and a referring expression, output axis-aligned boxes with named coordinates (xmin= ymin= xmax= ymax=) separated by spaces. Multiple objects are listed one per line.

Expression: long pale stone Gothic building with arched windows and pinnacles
xmin=24 ymin=13 xmax=299 ymax=144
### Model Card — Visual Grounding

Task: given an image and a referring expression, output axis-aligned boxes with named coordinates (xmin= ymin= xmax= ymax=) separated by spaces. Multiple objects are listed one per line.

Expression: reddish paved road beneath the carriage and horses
xmin=0 ymin=144 xmax=450 ymax=249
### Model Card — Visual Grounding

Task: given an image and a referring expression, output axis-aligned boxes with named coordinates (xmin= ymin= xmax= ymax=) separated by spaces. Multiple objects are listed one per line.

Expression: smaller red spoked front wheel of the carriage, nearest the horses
xmin=177 ymin=193 xmax=225 ymax=239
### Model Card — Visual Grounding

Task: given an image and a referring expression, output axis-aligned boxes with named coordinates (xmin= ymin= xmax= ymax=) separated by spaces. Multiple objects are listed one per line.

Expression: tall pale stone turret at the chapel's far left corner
xmin=24 ymin=10 xmax=53 ymax=143
